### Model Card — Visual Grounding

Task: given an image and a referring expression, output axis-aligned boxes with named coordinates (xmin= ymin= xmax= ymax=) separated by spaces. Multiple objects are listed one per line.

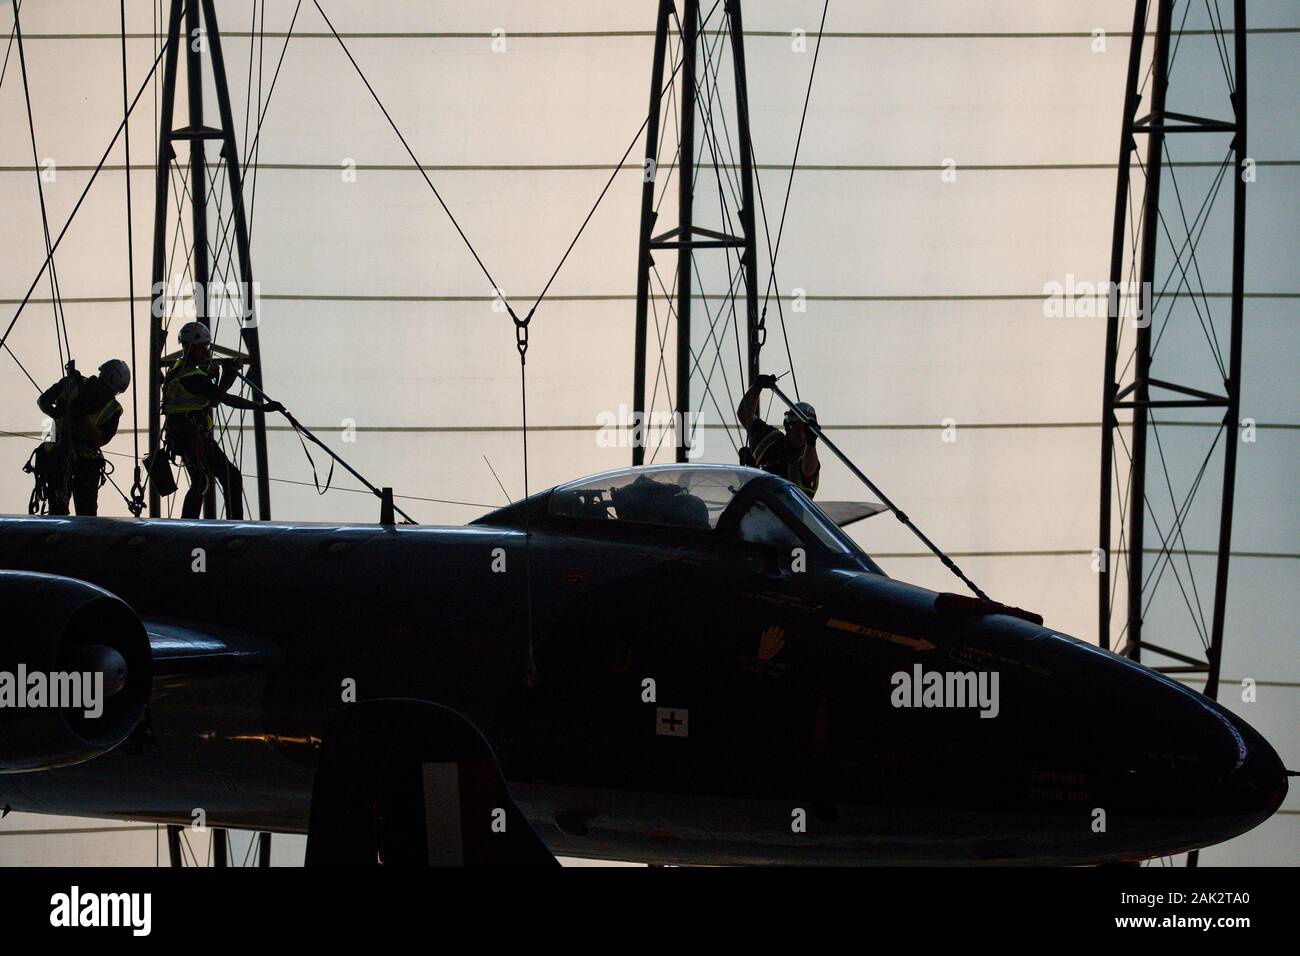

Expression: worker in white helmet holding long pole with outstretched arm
xmin=163 ymin=323 xmax=285 ymax=520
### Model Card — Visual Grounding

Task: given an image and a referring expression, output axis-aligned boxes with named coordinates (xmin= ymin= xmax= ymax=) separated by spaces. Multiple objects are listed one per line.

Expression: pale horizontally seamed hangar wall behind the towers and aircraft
xmin=0 ymin=0 xmax=1300 ymax=864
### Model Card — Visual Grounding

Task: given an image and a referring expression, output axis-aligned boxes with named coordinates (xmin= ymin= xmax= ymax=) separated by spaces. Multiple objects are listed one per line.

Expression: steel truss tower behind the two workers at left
xmin=150 ymin=0 xmax=270 ymax=520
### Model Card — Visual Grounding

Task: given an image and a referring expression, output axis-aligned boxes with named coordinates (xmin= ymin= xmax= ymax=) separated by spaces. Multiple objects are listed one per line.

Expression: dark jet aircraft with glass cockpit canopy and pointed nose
xmin=0 ymin=466 xmax=1287 ymax=864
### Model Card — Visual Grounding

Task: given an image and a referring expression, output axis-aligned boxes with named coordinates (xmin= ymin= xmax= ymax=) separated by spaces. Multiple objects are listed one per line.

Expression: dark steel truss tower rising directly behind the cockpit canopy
xmin=632 ymin=0 xmax=763 ymax=464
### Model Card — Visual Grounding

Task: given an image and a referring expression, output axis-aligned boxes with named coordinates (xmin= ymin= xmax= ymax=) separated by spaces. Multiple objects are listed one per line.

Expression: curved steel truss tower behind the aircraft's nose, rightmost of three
xmin=1097 ymin=0 xmax=1253 ymax=698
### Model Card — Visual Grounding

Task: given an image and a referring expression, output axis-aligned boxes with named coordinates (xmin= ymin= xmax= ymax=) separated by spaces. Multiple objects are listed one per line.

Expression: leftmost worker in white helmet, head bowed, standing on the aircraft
xmin=27 ymin=359 xmax=131 ymax=515
